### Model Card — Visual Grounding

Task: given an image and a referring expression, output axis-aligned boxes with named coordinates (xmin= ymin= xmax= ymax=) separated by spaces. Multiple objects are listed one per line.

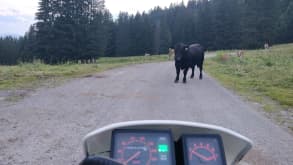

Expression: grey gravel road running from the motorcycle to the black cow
xmin=0 ymin=62 xmax=293 ymax=165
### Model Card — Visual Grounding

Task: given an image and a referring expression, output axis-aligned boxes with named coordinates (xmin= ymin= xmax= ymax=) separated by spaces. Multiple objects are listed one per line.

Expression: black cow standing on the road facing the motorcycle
xmin=175 ymin=43 xmax=205 ymax=83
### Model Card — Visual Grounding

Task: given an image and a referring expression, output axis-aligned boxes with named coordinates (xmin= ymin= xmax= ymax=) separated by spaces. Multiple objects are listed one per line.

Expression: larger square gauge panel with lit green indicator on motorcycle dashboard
xmin=111 ymin=130 xmax=175 ymax=165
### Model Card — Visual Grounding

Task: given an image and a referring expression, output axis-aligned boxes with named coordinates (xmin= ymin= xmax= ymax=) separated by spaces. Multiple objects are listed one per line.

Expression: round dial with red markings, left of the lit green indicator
xmin=117 ymin=137 xmax=157 ymax=165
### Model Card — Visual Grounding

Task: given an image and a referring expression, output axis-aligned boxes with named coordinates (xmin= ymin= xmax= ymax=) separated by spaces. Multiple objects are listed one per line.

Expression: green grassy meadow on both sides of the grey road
xmin=0 ymin=44 xmax=293 ymax=111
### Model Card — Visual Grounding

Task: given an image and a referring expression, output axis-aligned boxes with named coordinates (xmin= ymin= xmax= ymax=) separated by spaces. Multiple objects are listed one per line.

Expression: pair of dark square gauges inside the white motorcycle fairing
xmin=111 ymin=129 xmax=226 ymax=165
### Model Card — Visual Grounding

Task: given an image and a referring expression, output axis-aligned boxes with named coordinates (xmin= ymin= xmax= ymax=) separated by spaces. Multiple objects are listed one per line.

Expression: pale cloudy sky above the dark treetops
xmin=0 ymin=0 xmax=187 ymax=36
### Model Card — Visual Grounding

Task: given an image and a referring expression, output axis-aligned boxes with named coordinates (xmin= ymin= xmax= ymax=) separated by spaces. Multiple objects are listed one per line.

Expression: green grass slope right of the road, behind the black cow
xmin=205 ymin=44 xmax=293 ymax=108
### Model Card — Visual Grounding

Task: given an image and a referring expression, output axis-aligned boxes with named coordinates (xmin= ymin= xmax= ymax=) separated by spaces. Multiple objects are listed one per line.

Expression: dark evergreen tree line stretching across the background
xmin=0 ymin=0 xmax=293 ymax=64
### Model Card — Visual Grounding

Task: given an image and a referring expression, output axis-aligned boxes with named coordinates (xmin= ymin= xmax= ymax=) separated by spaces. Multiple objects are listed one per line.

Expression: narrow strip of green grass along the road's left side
xmin=0 ymin=55 xmax=168 ymax=90
